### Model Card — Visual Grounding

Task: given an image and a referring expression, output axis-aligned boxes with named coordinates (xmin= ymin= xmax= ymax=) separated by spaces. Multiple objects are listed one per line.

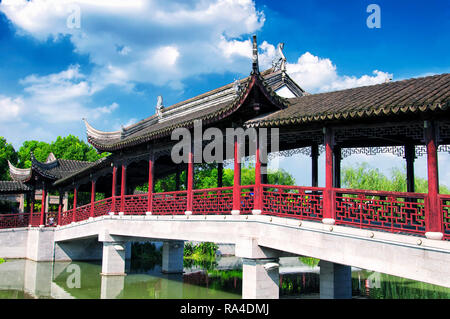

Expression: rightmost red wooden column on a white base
xmin=424 ymin=121 xmax=443 ymax=240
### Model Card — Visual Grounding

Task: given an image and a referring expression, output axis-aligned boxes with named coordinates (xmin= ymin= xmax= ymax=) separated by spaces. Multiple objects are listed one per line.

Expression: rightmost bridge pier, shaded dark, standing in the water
xmin=319 ymin=260 xmax=352 ymax=299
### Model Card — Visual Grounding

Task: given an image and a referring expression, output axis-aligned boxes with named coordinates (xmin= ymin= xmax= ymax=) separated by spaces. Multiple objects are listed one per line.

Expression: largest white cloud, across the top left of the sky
xmin=0 ymin=0 xmax=265 ymax=87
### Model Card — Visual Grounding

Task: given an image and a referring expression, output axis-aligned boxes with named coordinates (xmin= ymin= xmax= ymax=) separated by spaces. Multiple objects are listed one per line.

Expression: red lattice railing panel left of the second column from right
xmin=262 ymin=185 xmax=323 ymax=220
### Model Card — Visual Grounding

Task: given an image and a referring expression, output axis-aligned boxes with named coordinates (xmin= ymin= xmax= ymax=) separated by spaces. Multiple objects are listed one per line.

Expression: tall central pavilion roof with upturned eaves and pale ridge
xmin=85 ymin=68 xmax=300 ymax=151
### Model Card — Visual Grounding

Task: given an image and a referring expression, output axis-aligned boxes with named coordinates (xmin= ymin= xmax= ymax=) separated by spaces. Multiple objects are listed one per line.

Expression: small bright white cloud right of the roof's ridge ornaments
xmin=286 ymin=52 xmax=393 ymax=93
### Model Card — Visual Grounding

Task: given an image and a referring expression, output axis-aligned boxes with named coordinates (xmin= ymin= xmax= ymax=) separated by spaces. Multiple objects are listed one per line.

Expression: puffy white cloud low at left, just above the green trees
xmin=0 ymin=65 xmax=119 ymax=146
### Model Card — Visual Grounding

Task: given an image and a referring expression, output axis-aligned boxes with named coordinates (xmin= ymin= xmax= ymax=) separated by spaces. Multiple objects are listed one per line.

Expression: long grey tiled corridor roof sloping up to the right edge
xmin=246 ymin=73 xmax=450 ymax=127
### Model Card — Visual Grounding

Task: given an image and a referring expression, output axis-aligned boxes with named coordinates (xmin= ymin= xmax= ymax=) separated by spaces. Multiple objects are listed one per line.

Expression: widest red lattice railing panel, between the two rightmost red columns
xmin=334 ymin=189 xmax=428 ymax=235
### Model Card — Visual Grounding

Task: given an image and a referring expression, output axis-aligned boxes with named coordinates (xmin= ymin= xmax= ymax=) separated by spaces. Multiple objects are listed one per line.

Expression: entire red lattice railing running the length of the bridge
xmin=0 ymin=185 xmax=450 ymax=240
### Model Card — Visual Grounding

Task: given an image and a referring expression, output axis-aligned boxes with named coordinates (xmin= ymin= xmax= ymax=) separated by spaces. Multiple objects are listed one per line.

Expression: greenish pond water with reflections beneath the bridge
xmin=0 ymin=257 xmax=450 ymax=299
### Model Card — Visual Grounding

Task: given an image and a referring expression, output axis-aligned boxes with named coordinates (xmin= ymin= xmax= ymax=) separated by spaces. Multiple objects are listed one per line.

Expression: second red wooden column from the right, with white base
xmin=322 ymin=127 xmax=336 ymax=225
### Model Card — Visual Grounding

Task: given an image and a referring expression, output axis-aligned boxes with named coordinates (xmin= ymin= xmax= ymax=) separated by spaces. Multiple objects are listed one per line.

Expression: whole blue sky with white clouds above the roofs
xmin=0 ymin=0 xmax=450 ymax=188
